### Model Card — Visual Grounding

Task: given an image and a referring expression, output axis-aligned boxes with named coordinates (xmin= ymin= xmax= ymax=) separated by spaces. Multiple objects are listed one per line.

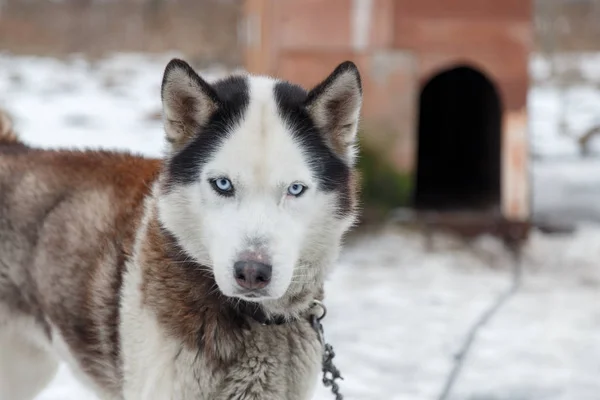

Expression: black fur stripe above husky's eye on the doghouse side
xmin=275 ymin=82 xmax=351 ymax=217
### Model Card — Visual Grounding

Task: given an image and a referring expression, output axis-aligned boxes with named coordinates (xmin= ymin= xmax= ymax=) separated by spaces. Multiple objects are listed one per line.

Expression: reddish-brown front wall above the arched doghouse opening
xmin=394 ymin=0 xmax=533 ymax=110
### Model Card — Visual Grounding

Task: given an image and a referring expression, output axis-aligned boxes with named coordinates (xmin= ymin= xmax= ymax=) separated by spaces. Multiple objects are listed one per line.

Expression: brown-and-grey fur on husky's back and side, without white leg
xmin=0 ymin=145 xmax=160 ymax=391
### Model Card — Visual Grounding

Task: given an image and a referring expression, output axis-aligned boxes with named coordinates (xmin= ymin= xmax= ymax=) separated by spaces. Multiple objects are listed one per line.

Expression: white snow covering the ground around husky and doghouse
xmin=0 ymin=54 xmax=600 ymax=400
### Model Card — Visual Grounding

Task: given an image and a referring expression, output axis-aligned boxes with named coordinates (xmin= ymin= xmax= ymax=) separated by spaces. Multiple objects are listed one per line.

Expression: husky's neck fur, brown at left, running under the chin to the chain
xmin=135 ymin=214 xmax=323 ymax=359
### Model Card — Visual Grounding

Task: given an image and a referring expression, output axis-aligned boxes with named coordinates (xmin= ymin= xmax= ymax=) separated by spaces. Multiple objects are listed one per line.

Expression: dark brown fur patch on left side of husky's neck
xmin=139 ymin=214 xmax=249 ymax=363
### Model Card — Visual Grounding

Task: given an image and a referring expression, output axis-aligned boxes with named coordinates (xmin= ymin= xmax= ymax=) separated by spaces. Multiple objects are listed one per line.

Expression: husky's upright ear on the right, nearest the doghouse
xmin=306 ymin=61 xmax=362 ymax=164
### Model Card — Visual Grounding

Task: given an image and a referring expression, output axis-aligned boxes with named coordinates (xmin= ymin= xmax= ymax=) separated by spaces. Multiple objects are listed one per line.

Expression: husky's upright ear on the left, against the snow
xmin=161 ymin=59 xmax=218 ymax=149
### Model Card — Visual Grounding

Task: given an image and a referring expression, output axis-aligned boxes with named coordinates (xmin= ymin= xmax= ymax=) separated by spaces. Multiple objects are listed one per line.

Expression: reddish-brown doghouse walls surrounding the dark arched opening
xmin=245 ymin=0 xmax=533 ymax=219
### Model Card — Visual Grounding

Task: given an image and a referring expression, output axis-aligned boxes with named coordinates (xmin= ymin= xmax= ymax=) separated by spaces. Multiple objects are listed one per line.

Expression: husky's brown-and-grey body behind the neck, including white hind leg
xmin=0 ymin=111 xmax=160 ymax=400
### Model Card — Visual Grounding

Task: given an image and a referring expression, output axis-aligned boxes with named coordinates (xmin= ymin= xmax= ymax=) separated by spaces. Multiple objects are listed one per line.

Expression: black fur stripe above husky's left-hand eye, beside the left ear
xmin=168 ymin=76 xmax=250 ymax=184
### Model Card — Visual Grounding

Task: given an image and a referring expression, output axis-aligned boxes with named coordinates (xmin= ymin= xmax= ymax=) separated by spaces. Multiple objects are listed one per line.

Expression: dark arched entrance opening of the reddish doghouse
xmin=413 ymin=67 xmax=502 ymax=211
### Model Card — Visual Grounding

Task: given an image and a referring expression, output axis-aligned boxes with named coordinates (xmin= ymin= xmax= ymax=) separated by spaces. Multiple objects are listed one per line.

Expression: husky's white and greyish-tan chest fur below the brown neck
xmin=122 ymin=296 xmax=322 ymax=400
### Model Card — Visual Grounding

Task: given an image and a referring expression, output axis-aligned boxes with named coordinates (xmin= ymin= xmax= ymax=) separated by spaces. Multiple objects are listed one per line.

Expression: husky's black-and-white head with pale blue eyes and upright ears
xmin=158 ymin=60 xmax=361 ymax=301
